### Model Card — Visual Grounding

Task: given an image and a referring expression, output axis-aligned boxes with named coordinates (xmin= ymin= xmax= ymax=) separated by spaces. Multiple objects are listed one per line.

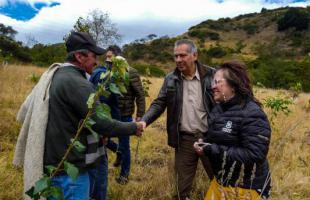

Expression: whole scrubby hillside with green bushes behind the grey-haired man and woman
xmin=124 ymin=7 xmax=310 ymax=92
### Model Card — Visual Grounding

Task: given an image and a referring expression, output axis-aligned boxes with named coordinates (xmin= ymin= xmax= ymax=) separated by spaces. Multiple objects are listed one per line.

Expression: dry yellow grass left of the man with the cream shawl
xmin=0 ymin=65 xmax=44 ymax=199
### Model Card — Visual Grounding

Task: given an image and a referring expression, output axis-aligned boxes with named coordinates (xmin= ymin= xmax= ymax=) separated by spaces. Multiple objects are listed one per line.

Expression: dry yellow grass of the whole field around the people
xmin=0 ymin=66 xmax=310 ymax=200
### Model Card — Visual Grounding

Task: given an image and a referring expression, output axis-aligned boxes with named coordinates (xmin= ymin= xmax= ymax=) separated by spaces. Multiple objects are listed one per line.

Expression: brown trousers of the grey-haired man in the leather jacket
xmin=175 ymin=134 xmax=213 ymax=200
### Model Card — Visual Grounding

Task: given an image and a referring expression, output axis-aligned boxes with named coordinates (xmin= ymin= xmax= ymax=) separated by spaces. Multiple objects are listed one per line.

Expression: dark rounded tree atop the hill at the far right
xmin=277 ymin=8 xmax=310 ymax=31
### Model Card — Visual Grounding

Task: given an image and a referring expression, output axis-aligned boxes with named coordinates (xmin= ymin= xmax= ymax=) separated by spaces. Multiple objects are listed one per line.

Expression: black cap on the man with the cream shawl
xmin=66 ymin=32 xmax=105 ymax=55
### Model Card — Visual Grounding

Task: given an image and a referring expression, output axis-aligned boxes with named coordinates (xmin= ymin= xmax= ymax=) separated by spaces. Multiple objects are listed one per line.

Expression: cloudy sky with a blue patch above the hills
xmin=0 ymin=0 xmax=310 ymax=44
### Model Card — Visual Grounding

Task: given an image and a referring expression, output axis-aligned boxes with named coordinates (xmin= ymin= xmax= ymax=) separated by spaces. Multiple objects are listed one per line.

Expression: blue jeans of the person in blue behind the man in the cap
xmin=88 ymin=155 xmax=108 ymax=200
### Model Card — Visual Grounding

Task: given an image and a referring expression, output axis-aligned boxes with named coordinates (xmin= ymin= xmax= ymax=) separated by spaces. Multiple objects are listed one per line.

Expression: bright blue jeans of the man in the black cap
xmin=47 ymin=172 xmax=89 ymax=200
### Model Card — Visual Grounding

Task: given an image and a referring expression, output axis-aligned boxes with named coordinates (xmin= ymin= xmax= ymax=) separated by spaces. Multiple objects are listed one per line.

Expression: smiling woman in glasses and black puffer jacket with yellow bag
xmin=194 ymin=61 xmax=271 ymax=200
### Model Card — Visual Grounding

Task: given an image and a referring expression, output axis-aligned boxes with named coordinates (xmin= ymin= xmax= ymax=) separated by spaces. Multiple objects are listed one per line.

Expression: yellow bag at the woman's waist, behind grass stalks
xmin=204 ymin=179 xmax=262 ymax=200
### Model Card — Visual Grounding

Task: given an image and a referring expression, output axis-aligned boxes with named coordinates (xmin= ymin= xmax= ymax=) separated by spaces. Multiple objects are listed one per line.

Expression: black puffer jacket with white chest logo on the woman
xmin=204 ymin=96 xmax=271 ymax=197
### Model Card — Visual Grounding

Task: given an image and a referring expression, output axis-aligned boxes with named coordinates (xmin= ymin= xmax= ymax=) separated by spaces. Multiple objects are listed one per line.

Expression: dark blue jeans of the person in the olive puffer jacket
xmin=118 ymin=116 xmax=132 ymax=177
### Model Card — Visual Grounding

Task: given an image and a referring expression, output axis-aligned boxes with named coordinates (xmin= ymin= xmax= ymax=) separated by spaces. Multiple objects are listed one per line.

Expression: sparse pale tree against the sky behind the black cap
xmin=68 ymin=9 xmax=121 ymax=47
